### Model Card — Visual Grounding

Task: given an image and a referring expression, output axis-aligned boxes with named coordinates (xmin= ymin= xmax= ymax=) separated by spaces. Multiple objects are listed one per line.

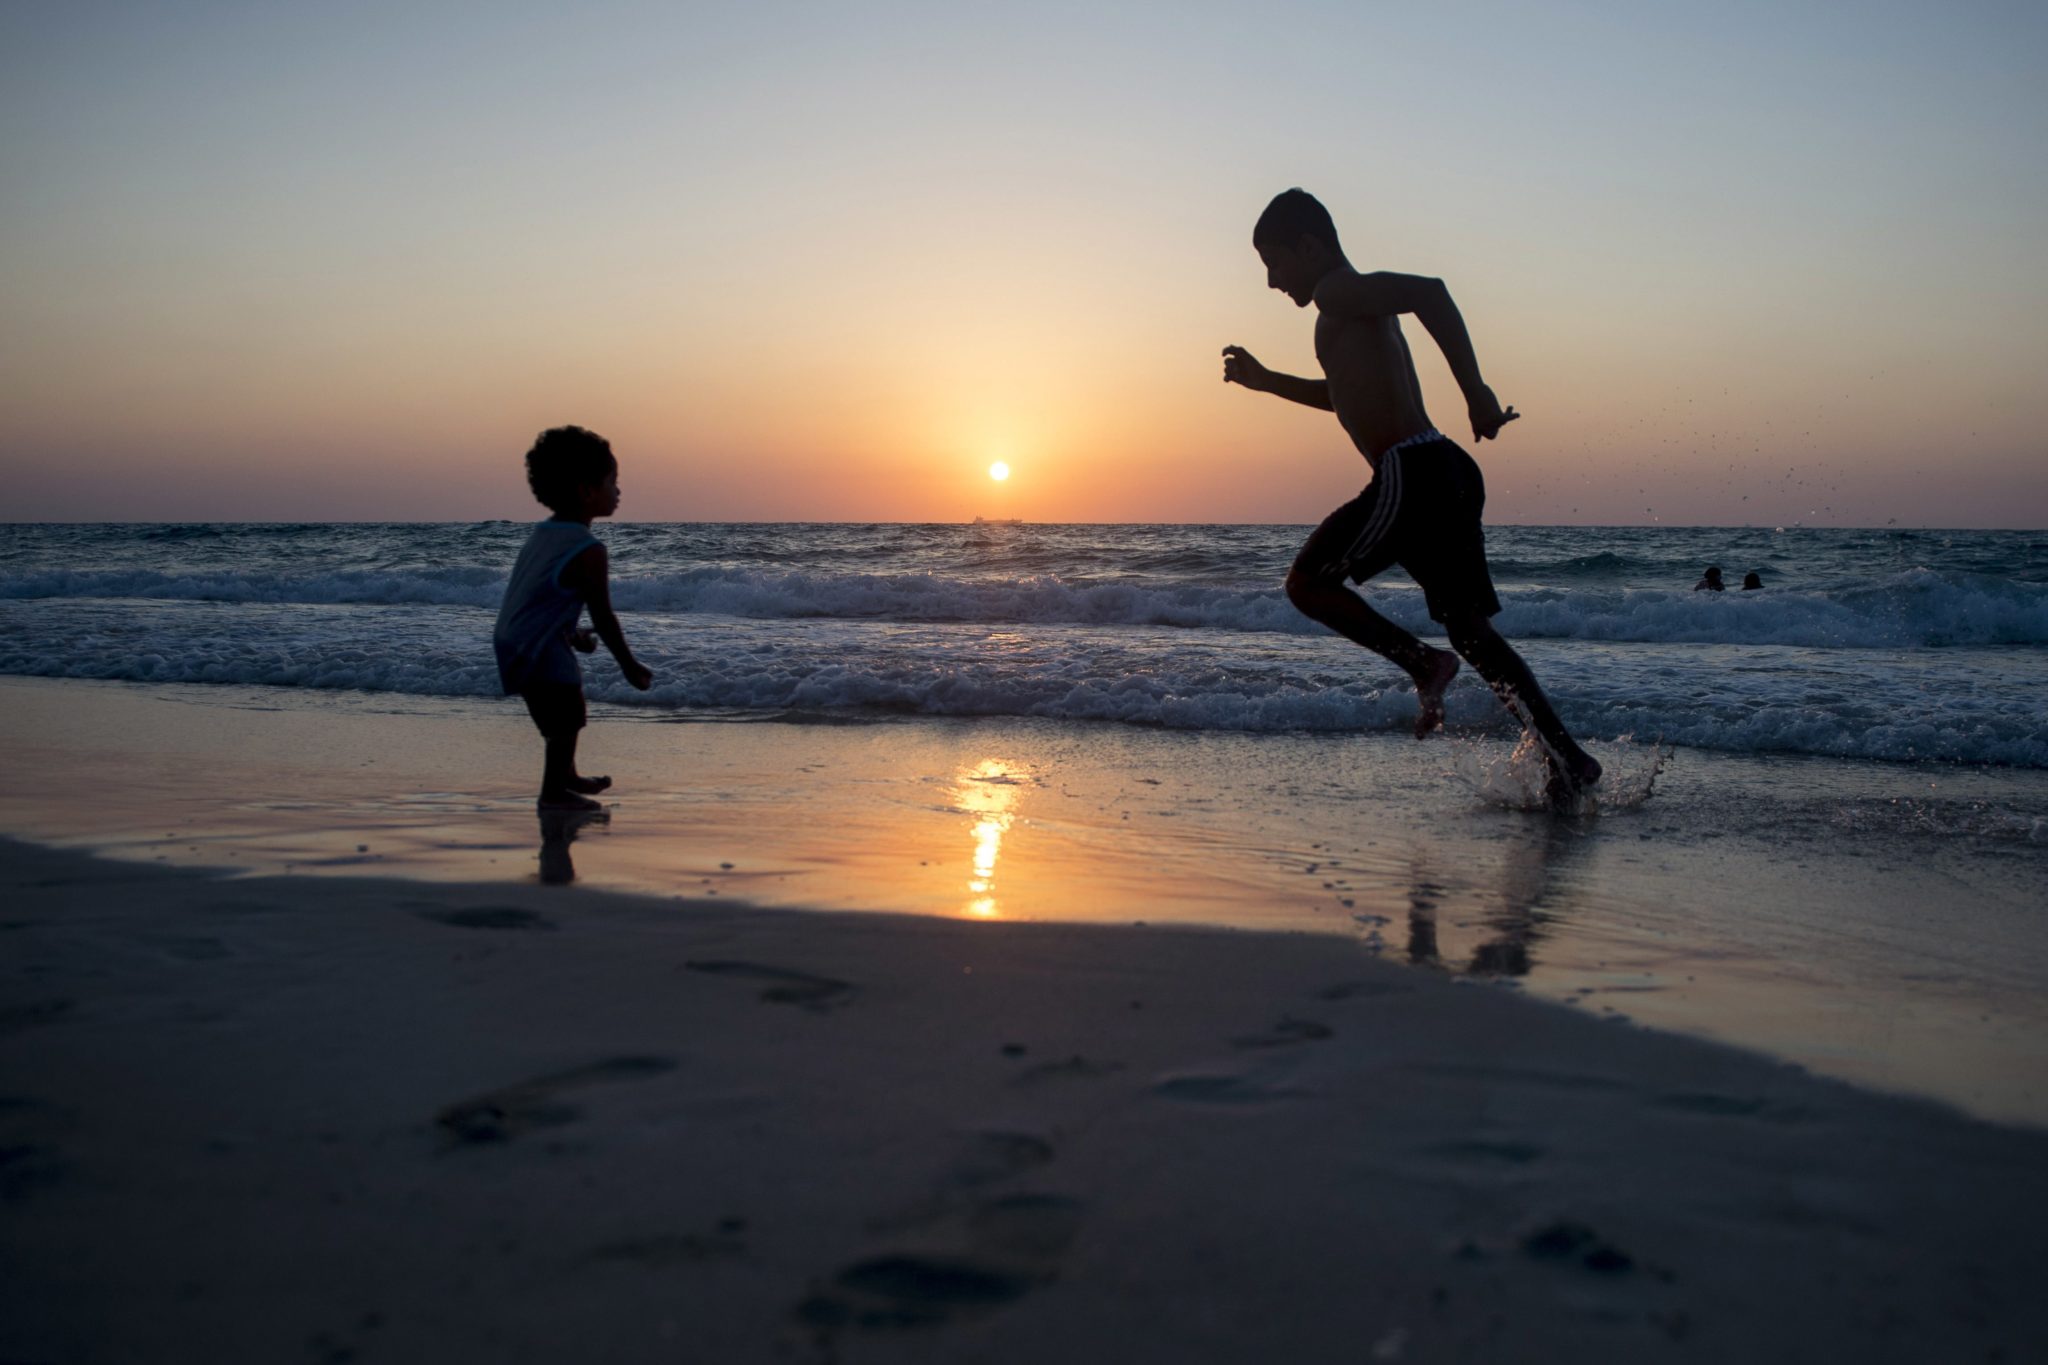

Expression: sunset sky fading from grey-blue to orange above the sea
xmin=0 ymin=0 xmax=2048 ymax=526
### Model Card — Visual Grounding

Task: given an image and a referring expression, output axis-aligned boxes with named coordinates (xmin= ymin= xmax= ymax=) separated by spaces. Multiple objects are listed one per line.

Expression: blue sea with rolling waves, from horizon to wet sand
xmin=0 ymin=522 xmax=2048 ymax=769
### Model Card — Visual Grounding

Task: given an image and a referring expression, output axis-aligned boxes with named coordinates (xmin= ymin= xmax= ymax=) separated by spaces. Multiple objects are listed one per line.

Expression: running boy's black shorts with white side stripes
xmin=1294 ymin=440 xmax=1501 ymax=620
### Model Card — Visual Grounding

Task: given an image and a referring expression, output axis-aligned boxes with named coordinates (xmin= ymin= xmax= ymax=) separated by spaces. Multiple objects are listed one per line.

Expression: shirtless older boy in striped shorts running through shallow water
xmin=1223 ymin=190 xmax=1599 ymax=800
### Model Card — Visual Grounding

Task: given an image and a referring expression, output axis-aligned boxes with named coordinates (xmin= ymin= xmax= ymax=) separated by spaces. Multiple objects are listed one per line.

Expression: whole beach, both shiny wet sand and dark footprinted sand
xmin=0 ymin=679 xmax=2048 ymax=1361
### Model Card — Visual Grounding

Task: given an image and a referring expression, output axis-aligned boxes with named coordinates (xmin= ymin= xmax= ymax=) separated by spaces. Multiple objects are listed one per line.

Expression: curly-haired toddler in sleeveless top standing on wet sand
xmin=492 ymin=426 xmax=653 ymax=810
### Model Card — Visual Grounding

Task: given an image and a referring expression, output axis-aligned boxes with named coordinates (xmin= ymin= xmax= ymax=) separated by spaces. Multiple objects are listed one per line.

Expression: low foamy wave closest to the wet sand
xmin=0 ymin=630 xmax=2048 ymax=767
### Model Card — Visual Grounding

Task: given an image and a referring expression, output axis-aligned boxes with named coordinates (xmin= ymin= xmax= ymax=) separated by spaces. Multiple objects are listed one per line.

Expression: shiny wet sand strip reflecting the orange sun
xmin=0 ymin=677 xmax=2048 ymax=1126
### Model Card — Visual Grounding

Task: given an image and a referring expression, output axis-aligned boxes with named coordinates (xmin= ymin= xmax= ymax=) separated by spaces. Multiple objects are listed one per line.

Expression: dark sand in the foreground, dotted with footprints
xmin=0 ymin=843 xmax=2048 ymax=1365
